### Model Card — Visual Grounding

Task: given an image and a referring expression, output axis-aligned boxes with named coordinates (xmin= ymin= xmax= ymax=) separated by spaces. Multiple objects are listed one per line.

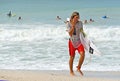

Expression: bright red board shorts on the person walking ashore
xmin=69 ymin=40 xmax=84 ymax=56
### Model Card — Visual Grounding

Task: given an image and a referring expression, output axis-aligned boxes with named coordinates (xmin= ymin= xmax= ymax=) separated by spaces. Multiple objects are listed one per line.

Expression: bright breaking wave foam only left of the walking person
xmin=0 ymin=25 xmax=66 ymax=41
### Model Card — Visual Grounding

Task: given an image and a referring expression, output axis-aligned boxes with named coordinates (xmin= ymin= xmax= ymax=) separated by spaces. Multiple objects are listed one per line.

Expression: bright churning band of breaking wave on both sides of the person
xmin=0 ymin=24 xmax=120 ymax=41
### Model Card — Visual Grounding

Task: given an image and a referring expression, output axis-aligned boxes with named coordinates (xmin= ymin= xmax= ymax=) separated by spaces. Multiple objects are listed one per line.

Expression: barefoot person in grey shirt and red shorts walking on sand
xmin=67 ymin=12 xmax=85 ymax=76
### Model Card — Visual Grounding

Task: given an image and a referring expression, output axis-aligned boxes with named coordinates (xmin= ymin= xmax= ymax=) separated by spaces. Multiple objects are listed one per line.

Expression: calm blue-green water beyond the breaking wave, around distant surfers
xmin=0 ymin=0 xmax=120 ymax=25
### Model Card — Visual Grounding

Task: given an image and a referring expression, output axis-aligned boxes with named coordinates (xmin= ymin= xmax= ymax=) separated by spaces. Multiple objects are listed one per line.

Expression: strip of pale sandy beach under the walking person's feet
xmin=0 ymin=70 xmax=120 ymax=81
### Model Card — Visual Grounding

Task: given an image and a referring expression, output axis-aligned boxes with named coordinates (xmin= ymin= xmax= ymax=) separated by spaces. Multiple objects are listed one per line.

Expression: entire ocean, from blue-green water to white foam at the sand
xmin=0 ymin=0 xmax=120 ymax=71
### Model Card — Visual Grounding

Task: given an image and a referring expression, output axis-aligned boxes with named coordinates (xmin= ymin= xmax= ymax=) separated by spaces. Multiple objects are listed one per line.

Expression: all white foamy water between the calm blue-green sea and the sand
xmin=0 ymin=24 xmax=120 ymax=71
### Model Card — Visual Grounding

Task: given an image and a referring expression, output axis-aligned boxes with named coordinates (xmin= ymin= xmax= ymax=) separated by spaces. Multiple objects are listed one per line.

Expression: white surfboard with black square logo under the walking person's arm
xmin=80 ymin=32 xmax=101 ymax=55
